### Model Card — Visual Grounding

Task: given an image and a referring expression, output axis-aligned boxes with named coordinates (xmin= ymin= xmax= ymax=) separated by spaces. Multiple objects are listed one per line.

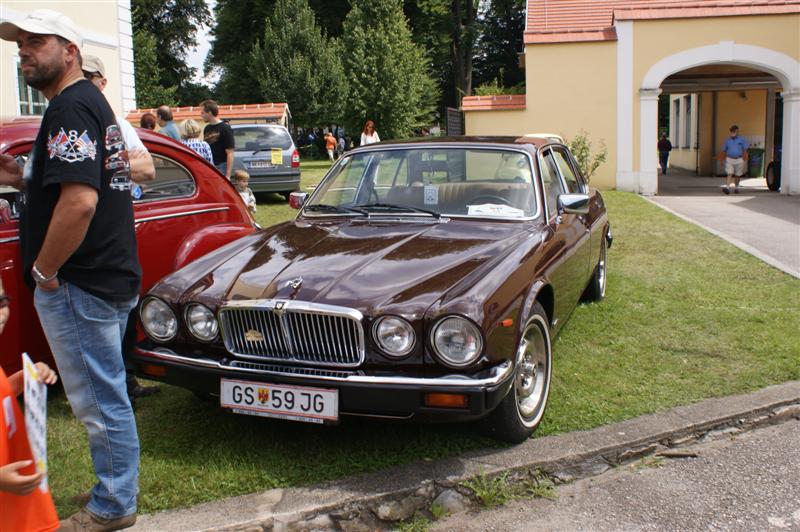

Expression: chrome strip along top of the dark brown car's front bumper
xmin=135 ymin=347 xmax=514 ymax=388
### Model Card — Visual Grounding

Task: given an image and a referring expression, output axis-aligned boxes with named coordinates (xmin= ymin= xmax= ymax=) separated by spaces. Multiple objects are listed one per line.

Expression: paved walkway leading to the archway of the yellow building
xmin=650 ymin=172 xmax=800 ymax=278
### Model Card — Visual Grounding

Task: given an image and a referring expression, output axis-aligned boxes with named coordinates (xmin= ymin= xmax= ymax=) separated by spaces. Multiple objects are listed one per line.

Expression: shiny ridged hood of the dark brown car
xmin=189 ymin=219 xmax=531 ymax=315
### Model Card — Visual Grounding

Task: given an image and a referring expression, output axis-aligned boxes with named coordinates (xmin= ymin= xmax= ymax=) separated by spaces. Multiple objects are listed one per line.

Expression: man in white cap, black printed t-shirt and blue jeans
xmin=0 ymin=9 xmax=141 ymax=530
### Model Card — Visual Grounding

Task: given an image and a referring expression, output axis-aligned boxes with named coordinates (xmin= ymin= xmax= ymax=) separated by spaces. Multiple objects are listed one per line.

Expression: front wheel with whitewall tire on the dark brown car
xmin=485 ymin=303 xmax=553 ymax=443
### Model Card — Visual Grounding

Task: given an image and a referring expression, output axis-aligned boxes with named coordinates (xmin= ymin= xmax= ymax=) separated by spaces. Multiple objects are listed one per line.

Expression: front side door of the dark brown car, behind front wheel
xmin=538 ymin=147 xmax=588 ymax=327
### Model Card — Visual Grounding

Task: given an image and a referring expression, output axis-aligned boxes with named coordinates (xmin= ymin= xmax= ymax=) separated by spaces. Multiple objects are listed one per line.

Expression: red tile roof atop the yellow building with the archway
xmin=524 ymin=0 xmax=800 ymax=44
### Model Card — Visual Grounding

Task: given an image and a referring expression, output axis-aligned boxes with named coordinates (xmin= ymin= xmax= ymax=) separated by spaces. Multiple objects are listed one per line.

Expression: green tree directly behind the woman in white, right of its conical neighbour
xmin=342 ymin=0 xmax=439 ymax=138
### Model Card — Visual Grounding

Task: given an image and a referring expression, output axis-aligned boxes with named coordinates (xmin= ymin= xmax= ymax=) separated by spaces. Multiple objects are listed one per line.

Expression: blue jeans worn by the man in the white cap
xmin=33 ymin=281 xmax=139 ymax=519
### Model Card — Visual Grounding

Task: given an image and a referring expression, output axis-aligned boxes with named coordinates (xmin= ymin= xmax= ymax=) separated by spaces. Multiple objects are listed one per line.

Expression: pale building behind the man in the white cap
xmin=0 ymin=0 xmax=136 ymax=117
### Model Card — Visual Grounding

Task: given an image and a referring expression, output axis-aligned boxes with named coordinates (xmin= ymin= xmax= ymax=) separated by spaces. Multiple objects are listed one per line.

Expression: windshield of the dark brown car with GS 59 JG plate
xmin=305 ymin=147 xmax=536 ymax=218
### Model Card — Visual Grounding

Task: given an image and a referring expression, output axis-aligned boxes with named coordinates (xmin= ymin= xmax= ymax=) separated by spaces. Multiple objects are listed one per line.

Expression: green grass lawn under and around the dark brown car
xmin=49 ymin=187 xmax=800 ymax=516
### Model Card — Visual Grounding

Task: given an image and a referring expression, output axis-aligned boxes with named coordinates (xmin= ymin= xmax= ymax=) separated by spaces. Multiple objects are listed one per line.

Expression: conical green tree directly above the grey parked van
xmin=249 ymin=0 xmax=347 ymax=126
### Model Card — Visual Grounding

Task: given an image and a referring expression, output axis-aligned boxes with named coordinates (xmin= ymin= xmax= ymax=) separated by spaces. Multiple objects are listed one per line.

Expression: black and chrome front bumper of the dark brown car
xmin=134 ymin=345 xmax=514 ymax=421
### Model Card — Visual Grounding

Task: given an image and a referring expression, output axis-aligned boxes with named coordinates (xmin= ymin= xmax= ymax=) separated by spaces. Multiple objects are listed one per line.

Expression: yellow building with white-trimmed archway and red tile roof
xmin=462 ymin=0 xmax=800 ymax=195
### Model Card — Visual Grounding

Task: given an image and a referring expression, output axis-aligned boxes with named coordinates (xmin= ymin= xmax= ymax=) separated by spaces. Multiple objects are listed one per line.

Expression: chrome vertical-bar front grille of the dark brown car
xmin=219 ymin=299 xmax=364 ymax=367
